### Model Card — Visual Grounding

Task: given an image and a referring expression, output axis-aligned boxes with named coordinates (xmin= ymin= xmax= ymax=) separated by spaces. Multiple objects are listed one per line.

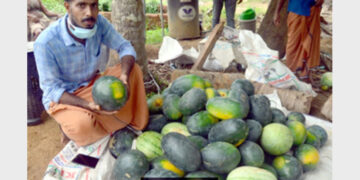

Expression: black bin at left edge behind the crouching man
xmin=27 ymin=51 xmax=44 ymax=126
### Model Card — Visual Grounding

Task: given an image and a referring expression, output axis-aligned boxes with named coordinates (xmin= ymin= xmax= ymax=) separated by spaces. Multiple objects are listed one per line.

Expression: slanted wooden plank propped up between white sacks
xmin=191 ymin=21 xmax=225 ymax=70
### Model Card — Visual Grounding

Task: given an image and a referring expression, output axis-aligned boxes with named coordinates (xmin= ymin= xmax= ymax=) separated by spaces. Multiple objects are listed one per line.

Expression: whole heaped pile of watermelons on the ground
xmin=109 ymin=74 xmax=327 ymax=180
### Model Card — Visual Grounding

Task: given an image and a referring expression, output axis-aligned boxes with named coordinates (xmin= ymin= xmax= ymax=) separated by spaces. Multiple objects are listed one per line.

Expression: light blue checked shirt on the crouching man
xmin=34 ymin=14 xmax=136 ymax=110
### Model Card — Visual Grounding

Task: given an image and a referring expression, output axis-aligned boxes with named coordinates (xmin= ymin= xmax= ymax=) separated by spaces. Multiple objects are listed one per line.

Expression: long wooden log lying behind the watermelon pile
xmin=171 ymin=70 xmax=313 ymax=114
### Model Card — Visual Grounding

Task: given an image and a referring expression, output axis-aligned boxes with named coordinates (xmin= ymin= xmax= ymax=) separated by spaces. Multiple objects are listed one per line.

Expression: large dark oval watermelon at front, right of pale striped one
xmin=161 ymin=132 xmax=201 ymax=172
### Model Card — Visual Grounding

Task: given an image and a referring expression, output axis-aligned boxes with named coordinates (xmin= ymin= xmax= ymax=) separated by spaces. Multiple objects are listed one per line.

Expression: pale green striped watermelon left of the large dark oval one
xmin=136 ymin=131 xmax=163 ymax=161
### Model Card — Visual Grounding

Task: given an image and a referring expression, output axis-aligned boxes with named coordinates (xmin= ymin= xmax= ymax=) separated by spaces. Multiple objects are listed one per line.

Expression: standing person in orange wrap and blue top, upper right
xmin=273 ymin=0 xmax=324 ymax=82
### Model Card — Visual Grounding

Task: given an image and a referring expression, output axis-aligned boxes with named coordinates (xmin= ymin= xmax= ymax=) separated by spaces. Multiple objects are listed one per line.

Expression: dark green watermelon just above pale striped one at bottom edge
xmin=239 ymin=141 xmax=265 ymax=167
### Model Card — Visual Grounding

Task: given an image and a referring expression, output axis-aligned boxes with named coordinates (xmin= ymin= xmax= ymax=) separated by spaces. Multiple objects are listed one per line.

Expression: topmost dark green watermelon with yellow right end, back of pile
xmin=170 ymin=74 xmax=205 ymax=97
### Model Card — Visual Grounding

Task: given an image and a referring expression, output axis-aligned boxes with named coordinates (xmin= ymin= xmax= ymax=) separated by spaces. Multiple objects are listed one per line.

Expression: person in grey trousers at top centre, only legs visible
xmin=212 ymin=0 xmax=242 ymax=28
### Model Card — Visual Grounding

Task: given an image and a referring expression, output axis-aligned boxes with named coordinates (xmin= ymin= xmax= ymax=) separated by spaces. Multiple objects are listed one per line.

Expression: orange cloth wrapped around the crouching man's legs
xmin=48 ymin=64 xmax=149 ymax=146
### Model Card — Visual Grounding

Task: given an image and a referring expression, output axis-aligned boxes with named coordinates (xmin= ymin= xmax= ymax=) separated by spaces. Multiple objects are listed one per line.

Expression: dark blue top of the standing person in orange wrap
xmin=288 ymin=0 xmax=315 ymax=16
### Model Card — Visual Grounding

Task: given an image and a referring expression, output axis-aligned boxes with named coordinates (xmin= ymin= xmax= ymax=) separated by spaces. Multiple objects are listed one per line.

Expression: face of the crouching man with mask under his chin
xmin=64 ymin=0 xmax=99 ymax=29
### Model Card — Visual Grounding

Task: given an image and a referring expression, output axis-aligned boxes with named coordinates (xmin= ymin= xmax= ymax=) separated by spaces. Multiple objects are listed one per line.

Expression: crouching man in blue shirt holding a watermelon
xmin=34 ymin=0 xmax=148 ymax=146
